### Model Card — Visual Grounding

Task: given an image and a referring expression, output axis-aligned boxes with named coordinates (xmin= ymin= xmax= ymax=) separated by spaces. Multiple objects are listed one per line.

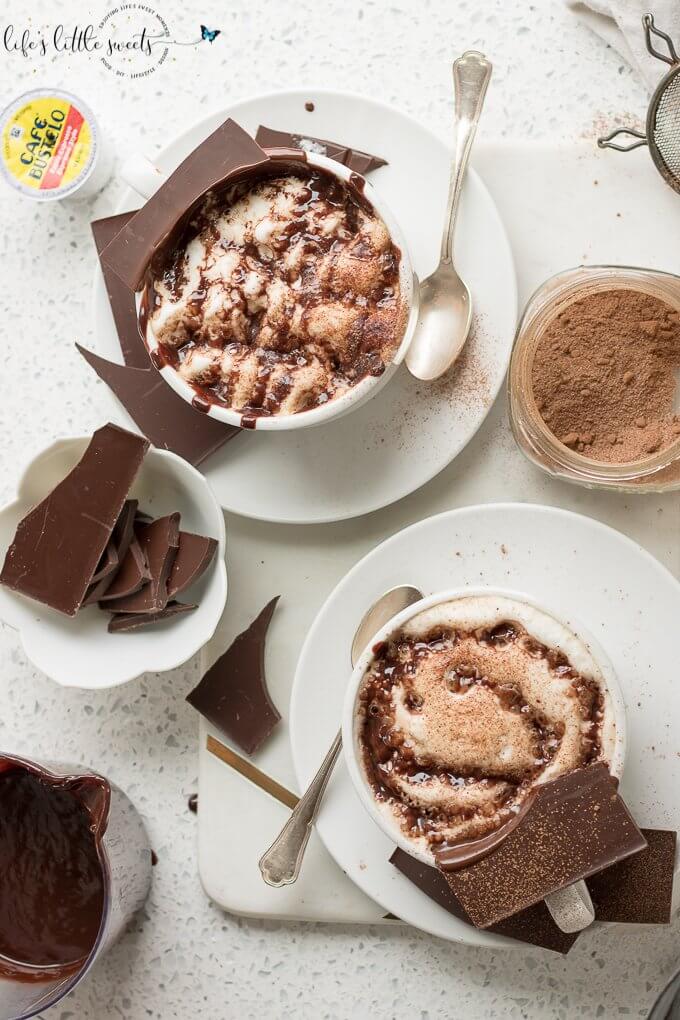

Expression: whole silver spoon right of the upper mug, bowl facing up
xmin=406 ymin=50 xmax=491 ymax=380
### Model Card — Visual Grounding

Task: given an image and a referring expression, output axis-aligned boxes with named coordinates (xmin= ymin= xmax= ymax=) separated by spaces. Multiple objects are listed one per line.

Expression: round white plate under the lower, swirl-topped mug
xmin=290 ymin=503 xmax=680 ymax=948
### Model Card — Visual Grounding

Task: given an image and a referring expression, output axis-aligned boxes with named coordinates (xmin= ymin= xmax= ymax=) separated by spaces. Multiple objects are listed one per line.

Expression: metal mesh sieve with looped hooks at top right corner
xmin=597 ymin=14 xmax=680 ymax=193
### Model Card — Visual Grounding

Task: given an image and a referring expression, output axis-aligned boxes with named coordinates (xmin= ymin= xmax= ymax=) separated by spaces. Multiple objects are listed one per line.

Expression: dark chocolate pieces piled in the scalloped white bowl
xmin=0 ymin=424 xmax=217 ymax=632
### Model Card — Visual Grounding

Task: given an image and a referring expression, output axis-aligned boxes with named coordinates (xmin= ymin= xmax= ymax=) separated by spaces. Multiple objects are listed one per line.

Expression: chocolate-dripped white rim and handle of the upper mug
xmin=121 ymin=149 xmax=418 ymax=431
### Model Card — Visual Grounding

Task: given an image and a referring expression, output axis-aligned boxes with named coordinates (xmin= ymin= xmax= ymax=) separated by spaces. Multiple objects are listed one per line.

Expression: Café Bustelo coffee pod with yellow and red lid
xmin=0 ymin=89 xmax=107 ymax=202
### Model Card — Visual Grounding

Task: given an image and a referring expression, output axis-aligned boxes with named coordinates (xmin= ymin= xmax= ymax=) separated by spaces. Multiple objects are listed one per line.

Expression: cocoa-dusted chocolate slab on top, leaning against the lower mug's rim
xmin=434 ymin=762 xmax=646 ymax=928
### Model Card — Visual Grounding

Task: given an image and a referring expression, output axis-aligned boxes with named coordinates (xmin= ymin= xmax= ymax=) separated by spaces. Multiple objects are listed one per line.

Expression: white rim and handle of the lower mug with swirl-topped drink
xmin=343 ymin=588 xmax=626 ymax=931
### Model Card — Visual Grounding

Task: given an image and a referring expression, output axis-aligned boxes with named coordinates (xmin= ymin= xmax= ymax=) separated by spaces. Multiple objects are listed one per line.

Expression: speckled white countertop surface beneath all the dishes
xmin=0 ymin=0 xmax=680 ymax=1020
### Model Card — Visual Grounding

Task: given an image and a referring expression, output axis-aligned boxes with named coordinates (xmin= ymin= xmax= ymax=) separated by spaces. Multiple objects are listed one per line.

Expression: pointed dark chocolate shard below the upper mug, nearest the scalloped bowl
xmin=75 ymin=344 xmax=241 ymax=466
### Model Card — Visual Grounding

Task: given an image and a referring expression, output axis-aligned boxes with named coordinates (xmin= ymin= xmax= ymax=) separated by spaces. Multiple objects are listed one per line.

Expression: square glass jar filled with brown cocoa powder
xmin=508 ymin=265 xmax=680 ymax=493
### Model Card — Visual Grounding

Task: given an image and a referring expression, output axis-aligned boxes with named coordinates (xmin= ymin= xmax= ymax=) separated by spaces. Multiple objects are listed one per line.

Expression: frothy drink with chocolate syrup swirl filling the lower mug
xmin=354 ymin=595 xmax=616 ymax=858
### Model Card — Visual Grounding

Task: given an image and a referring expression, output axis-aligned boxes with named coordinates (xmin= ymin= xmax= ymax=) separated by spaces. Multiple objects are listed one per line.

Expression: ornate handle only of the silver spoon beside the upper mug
xmin=440 ymin=50 xmax=491 ymax=262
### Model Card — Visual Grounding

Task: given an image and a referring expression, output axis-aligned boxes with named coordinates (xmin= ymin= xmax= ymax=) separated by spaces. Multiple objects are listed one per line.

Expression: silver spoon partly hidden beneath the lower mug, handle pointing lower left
xmin=259 ymin=584 xmax=423 ymax=888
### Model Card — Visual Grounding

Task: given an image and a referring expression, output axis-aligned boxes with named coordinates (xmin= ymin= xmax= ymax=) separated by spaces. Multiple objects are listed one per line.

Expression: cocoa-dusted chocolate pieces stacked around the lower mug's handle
xmin=390 ymin=762 xmax=676 ymax=953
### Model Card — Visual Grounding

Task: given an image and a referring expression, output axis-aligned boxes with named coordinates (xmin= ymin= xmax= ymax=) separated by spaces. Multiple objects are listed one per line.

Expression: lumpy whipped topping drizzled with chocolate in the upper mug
xmin=148 ymin=167 xmax=406 ymax=416
